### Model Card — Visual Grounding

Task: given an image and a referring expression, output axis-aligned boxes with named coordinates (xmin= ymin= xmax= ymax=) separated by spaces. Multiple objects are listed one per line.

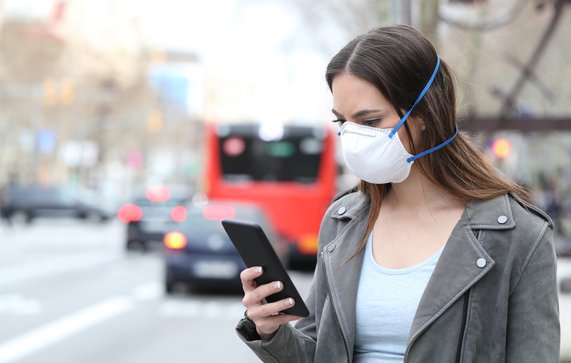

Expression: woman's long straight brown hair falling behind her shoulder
xmin=325 ymin=25 xmax=531 ymax=250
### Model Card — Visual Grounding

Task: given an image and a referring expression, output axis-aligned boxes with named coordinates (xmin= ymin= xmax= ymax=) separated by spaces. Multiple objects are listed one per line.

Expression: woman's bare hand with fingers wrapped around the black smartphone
xmin=240 ymin=267 xmax=299 ymax=340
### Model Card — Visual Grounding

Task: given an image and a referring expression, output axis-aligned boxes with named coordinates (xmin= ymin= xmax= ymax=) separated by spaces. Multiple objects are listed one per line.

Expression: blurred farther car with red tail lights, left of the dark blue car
xmin=117 ymin=187 xmax=192 ymax=251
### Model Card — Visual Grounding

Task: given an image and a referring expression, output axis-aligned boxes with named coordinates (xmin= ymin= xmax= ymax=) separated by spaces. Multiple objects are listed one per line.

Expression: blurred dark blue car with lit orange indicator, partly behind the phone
xmin=164 ymin=201 xmax=289 ymax=293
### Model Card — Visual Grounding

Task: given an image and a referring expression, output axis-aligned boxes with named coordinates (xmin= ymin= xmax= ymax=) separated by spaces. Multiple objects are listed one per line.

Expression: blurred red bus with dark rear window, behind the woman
xmin=205 ymin=123 xmax=336 ymax=263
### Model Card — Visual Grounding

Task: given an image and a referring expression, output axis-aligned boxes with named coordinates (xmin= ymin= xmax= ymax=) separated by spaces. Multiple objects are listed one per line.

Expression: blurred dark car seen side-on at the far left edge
xmin=1 ymin=184 xmax=113 ymax=223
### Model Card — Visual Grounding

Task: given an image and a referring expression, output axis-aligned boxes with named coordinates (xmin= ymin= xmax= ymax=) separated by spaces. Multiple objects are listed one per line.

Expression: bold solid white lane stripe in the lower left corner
xmin=0 ymin=297 xmax=133 ymax=363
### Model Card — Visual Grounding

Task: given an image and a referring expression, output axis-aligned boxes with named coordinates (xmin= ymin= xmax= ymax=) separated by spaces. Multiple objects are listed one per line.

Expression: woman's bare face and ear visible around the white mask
xmin=331 ymin=73 xmax=422 ymax=153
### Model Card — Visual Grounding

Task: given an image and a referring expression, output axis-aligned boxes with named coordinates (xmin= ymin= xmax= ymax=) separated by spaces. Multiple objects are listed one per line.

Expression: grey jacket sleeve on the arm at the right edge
xmin=506 ymin=223 xmax=560 ymax=363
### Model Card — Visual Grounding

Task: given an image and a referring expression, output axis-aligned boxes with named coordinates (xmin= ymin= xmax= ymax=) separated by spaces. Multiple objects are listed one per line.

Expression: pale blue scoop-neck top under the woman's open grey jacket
xmin=354 ymin=235 xmax=444 ymax=363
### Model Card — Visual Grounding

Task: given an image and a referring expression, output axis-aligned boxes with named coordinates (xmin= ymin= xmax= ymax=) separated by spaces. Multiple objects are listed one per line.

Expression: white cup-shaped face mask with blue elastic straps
xmin=339 ymin=58 xmax=458 ymax=184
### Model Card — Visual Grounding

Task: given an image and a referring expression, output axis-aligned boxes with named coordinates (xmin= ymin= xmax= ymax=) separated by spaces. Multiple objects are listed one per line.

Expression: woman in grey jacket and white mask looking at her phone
xmin=237 ymin=26 xmax=560 ymax=363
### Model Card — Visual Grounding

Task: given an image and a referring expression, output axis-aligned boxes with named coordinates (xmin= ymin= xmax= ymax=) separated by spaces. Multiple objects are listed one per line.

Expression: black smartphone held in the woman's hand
xmin=222 ymin=219 xmax=309 ymax=317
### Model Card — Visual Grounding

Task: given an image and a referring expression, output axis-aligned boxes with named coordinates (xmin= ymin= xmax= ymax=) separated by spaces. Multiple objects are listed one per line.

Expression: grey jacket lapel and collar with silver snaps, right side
xmin=408 ymin=196 xmax=515 ymax=348
